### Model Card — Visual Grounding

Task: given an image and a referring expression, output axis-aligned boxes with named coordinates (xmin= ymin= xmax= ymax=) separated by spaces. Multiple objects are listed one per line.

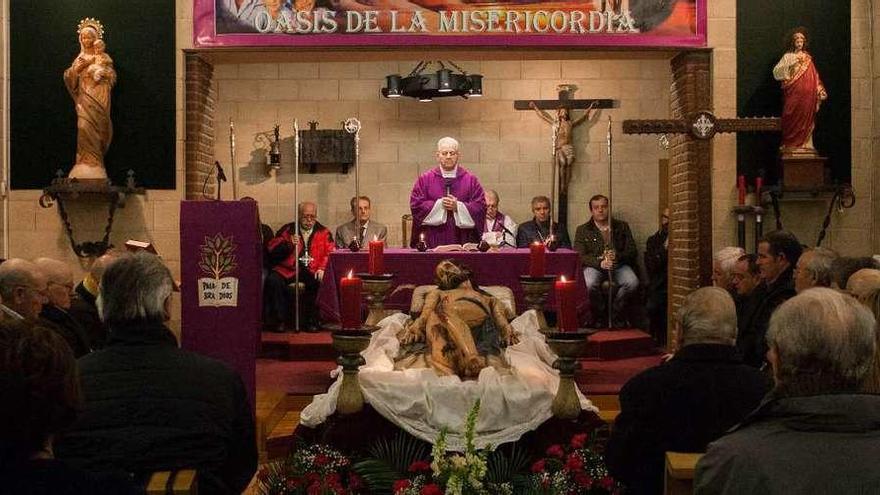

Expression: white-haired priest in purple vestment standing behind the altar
xmin=409 ymin=137 xmax=486 ymax=247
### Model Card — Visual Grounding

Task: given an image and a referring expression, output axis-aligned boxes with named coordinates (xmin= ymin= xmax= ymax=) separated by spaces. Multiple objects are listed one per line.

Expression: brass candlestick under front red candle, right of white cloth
xmin=547 ymin=329 xmax=590 ymax=419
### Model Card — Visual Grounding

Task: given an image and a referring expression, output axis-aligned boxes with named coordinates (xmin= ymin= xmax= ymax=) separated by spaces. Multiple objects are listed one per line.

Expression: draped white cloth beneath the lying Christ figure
xmin=300 ymin=310 xmax=598 ymax=451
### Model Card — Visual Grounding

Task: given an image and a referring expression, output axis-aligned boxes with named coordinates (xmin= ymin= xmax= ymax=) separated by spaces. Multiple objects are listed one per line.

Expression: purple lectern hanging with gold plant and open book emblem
xmin=180 ymin=201 xmax=262 ymax=408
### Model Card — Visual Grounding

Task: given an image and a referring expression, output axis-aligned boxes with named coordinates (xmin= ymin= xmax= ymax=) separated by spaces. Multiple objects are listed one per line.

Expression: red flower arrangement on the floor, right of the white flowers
xmin=530 ymin=433 xmax=621 ymax=495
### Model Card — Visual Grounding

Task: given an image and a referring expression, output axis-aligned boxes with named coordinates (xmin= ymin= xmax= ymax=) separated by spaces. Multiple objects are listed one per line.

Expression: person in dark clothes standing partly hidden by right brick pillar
xmin=645 ymin=208 xmax=669 ymax=345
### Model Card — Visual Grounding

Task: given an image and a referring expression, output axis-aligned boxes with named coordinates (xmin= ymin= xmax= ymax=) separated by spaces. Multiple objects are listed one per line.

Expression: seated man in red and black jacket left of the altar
xmin=263 ymin=201 xmax=334 ymax=332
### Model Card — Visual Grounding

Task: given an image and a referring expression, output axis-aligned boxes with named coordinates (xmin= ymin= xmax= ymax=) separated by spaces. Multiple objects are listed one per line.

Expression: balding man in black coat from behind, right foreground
xmin=605 ymin=287 xmax=770 ymax=494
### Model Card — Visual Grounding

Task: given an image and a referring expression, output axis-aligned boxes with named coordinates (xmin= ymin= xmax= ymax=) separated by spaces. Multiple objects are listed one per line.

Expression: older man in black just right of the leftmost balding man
xmin=34 ymin=258 xmax=92 ymax=358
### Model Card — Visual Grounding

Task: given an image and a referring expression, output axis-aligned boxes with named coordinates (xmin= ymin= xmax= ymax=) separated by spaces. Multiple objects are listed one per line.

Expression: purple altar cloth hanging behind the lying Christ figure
xmin=317 ymin=248 xmax=589 ymax=323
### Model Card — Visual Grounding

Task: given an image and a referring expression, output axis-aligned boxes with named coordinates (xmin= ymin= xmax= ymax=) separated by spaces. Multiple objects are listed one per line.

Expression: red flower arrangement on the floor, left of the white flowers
xmin=257 ymin=445 xmax=369 ymax=495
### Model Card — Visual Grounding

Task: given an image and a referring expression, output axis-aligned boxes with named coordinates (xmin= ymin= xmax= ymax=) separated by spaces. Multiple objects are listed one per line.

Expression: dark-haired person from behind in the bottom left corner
xmin=0 ymin=319 xmax=138 ymax=495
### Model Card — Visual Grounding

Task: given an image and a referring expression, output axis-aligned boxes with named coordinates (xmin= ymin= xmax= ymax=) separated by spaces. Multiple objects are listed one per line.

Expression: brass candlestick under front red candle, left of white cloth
xmin=331 ymin=327 xmax=370 ymax=414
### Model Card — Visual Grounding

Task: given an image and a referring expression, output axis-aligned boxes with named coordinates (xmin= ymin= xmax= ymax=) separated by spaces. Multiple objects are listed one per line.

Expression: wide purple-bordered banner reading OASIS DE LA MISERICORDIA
xmin=193 ymin=0 xmax=708 ymax=47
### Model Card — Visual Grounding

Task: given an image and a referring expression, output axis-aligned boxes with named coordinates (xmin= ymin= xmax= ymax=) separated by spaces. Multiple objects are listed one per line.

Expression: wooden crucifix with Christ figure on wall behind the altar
xmin=513 ymin=84 xmax=617 ymax=228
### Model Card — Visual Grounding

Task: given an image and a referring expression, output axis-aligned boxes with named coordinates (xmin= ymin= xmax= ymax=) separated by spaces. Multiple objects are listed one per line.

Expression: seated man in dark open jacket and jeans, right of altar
xmin=574 ymin=194 xmax=639 ymax=328
